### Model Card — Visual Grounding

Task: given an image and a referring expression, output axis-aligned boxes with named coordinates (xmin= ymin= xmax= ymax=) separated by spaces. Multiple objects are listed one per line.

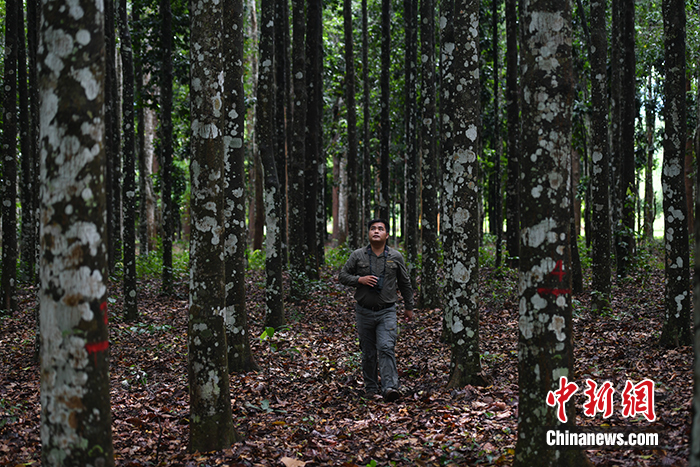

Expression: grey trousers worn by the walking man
xmin=355 ymin=304 xmax=399 ymax=394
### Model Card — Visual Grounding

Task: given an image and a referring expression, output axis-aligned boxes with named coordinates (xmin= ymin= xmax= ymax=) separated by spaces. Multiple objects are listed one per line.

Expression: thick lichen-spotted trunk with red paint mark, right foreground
xmin=513 ymin=0 xmax=586 ymax=466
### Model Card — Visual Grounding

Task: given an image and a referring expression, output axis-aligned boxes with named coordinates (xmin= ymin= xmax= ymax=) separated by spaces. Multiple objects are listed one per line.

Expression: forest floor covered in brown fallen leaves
xmin=0 ymin=243 xmax=693 ymax=467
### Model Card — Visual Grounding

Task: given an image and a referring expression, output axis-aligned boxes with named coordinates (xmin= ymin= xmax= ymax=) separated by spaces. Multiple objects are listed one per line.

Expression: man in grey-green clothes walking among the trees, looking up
xmin=338 ymin=219 xmax=413 ymax=402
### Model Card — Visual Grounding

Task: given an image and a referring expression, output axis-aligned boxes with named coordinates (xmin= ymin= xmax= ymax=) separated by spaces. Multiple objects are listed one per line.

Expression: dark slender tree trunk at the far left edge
xmin=0 ymin=0 xmax=19 ymax=313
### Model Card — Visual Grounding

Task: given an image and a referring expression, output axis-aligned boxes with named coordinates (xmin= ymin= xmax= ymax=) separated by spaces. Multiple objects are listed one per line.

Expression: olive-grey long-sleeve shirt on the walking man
xmin=338 ymin=247 xmax=414 ymax=310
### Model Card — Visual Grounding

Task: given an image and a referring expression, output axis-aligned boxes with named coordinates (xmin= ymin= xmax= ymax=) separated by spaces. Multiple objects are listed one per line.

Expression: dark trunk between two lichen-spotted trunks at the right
xmin=616 ymin=0 xmax=637 ymax=277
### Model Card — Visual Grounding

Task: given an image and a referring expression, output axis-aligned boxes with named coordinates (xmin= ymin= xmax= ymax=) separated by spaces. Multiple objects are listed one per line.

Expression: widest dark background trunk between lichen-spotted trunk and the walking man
xmin=304 ymin=0 xmax=325 ymax=279
